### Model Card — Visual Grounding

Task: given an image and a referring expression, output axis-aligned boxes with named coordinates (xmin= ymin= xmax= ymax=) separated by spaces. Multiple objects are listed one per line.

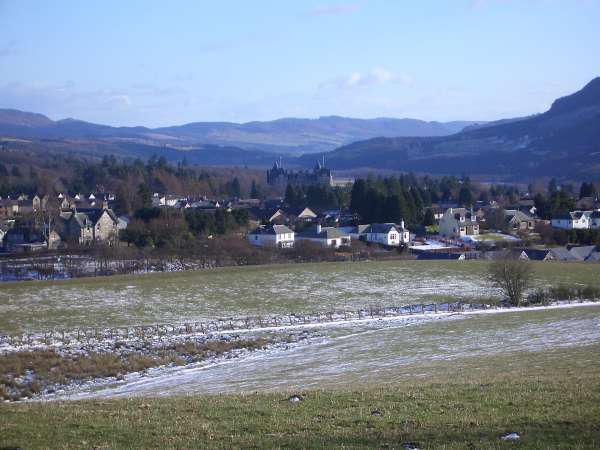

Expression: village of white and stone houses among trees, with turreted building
xmin=0 ymin=161 xmax=600 ymax=268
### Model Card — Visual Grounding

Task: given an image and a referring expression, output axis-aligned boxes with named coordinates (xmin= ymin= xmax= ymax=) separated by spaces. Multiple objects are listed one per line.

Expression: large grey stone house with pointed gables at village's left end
xmin=60 ymin=208 xmax=119 ymax=244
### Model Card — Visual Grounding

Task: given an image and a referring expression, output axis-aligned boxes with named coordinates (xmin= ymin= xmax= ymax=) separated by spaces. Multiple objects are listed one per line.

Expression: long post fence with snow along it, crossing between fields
xmin=0 ymin=302 xmax=497 ymax=349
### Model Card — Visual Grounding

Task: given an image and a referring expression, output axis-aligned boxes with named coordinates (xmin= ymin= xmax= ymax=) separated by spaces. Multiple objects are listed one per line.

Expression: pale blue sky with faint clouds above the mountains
xmin=0 ymin=0 xmax=600 ymax=127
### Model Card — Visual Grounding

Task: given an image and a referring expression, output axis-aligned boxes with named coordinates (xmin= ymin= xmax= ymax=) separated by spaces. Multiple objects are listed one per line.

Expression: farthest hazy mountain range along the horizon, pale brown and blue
xmin=0 ymin=109 xmax=475 ymax=155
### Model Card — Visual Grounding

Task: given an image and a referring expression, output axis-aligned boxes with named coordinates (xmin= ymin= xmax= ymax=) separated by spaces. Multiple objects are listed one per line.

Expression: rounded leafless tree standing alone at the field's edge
xmin=489 ymin=253 xmax=533 ymax=306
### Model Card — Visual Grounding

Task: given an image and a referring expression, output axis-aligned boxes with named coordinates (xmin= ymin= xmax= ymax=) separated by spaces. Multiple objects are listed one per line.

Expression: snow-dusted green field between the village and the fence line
xmin=0 ymin=261 xmax=600 ymax=333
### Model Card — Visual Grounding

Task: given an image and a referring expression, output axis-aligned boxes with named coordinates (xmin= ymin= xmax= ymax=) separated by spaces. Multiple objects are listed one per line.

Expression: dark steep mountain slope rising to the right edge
xmin=299 ymin=77 xmax=600 ymax=179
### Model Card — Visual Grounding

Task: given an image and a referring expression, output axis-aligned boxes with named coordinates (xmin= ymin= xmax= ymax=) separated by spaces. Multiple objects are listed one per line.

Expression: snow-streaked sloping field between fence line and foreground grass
xmin=51 ymin=303 xmax=600 ymax=399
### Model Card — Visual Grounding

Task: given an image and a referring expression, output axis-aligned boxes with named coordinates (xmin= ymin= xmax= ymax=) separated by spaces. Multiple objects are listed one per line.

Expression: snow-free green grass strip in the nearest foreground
xmin=0 ymin=344 xmax=600 ymax=449
